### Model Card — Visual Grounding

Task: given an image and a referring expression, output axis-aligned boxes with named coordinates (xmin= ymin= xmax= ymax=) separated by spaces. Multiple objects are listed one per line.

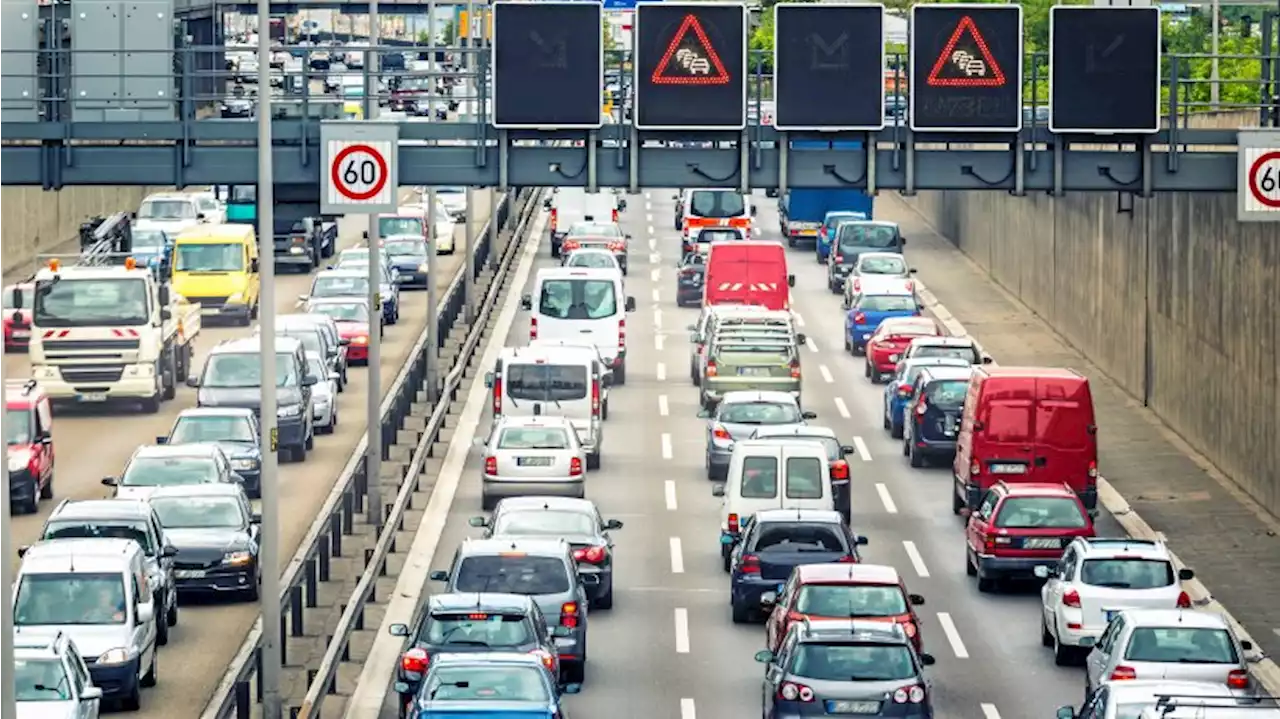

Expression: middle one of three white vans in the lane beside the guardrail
xmin=520 ymin=267 xmax=636 ymax=385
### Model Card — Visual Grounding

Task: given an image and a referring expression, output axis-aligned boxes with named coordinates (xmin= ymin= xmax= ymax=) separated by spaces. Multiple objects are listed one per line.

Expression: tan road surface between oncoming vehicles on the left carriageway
xmin=5 ymin=191 xmax=489 ymax=719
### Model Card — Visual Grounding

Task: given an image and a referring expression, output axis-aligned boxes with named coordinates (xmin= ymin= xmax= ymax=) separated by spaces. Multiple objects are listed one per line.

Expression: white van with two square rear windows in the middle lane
xmin=712 ymin=440 xmax=836 ymax=572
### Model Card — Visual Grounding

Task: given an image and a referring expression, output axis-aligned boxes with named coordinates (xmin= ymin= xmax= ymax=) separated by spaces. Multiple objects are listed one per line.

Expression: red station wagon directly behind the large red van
xmin=963 ymin=482 xmax=1094 ymax=591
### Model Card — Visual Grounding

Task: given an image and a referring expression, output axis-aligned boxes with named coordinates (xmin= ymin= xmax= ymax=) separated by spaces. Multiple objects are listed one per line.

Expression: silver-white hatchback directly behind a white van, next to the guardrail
xmin=480 ymin=415 xmax=586 ymax=509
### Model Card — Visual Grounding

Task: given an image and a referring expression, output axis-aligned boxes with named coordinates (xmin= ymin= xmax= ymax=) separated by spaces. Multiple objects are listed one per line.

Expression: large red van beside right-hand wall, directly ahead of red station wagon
xmin=951 ymin=367 xmax=1098 ymax=513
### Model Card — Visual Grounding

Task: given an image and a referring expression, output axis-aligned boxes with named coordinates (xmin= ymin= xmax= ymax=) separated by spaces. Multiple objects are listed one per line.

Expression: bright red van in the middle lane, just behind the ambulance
xmin=703 ymin=241 xmax=796 ymax=310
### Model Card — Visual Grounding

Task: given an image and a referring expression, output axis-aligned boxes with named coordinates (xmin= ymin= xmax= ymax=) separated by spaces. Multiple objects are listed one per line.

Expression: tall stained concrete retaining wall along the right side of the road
xmin=905 ymin=114 xmax=1280 ymax=514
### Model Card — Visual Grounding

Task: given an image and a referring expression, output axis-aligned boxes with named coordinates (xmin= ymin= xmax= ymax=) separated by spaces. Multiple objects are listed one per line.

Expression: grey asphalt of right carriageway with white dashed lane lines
xmin=366 ymin=189 xmax=1123 ymax=719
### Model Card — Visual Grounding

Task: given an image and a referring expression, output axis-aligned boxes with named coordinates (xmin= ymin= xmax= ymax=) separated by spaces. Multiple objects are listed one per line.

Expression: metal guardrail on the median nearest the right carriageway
xmin=294 ymin=182 xmax=541 ymax=719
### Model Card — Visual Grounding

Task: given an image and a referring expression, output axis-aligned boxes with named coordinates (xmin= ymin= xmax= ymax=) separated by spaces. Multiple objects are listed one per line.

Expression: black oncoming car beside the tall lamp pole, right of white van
xmin=147 ymin=485 xmax=262 ymax=601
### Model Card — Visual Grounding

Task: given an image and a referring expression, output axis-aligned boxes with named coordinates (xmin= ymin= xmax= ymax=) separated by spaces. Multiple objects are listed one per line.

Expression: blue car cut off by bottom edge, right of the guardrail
xmin=396 ymin=652 xmax=581 ymax=719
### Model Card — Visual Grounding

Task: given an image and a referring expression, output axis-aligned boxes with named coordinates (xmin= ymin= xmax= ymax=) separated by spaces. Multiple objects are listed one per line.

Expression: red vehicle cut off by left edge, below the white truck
xmin=5 ymin=380 xmax=54 ymax=514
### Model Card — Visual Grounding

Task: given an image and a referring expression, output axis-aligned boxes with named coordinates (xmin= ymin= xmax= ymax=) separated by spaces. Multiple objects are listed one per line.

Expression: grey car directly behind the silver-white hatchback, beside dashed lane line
xmin=471 ymin=496 xmax=622 ymax=609
